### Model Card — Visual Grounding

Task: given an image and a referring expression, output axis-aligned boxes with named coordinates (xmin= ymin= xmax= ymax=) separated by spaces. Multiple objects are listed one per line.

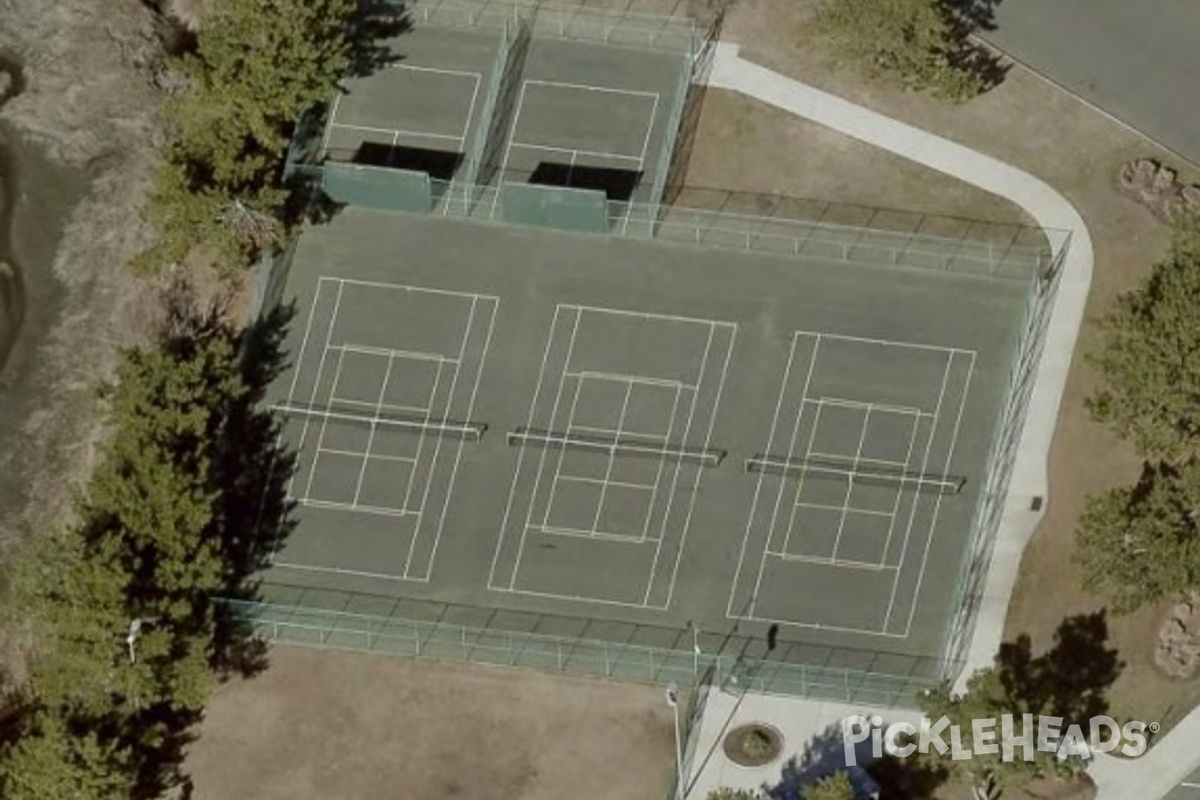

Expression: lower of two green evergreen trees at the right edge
xmin=1074 ymin=462 xmax=1200 ymax=613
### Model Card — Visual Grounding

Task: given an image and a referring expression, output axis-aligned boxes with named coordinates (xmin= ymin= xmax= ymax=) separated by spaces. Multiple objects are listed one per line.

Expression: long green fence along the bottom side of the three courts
xmin=222 ymin=590 xmax=943 ymax=708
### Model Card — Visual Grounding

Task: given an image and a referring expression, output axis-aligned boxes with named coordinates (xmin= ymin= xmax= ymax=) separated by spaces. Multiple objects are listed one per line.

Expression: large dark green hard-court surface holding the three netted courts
xmin=266 ymin=209 xmax=1030 ymax=674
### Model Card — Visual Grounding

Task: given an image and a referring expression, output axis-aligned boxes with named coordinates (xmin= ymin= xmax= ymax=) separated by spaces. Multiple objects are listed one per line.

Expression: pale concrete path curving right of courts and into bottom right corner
xmin=709 ymin=43 xmax=1200 ymax=800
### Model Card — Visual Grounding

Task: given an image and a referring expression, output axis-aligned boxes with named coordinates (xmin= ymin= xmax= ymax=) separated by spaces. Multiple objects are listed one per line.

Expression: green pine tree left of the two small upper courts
xmin=134 ymin=0 xmax=356 ymax=269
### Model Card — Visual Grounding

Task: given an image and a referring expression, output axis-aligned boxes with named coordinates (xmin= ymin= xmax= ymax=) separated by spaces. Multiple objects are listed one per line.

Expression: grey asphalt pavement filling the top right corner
xmin=982 ymin=0 xmax=1200 ymax=164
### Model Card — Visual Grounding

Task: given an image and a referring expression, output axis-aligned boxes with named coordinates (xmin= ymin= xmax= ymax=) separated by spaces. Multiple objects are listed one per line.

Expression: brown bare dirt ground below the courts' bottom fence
xmin=187 ymin=646 xmax=674 ymax=800
